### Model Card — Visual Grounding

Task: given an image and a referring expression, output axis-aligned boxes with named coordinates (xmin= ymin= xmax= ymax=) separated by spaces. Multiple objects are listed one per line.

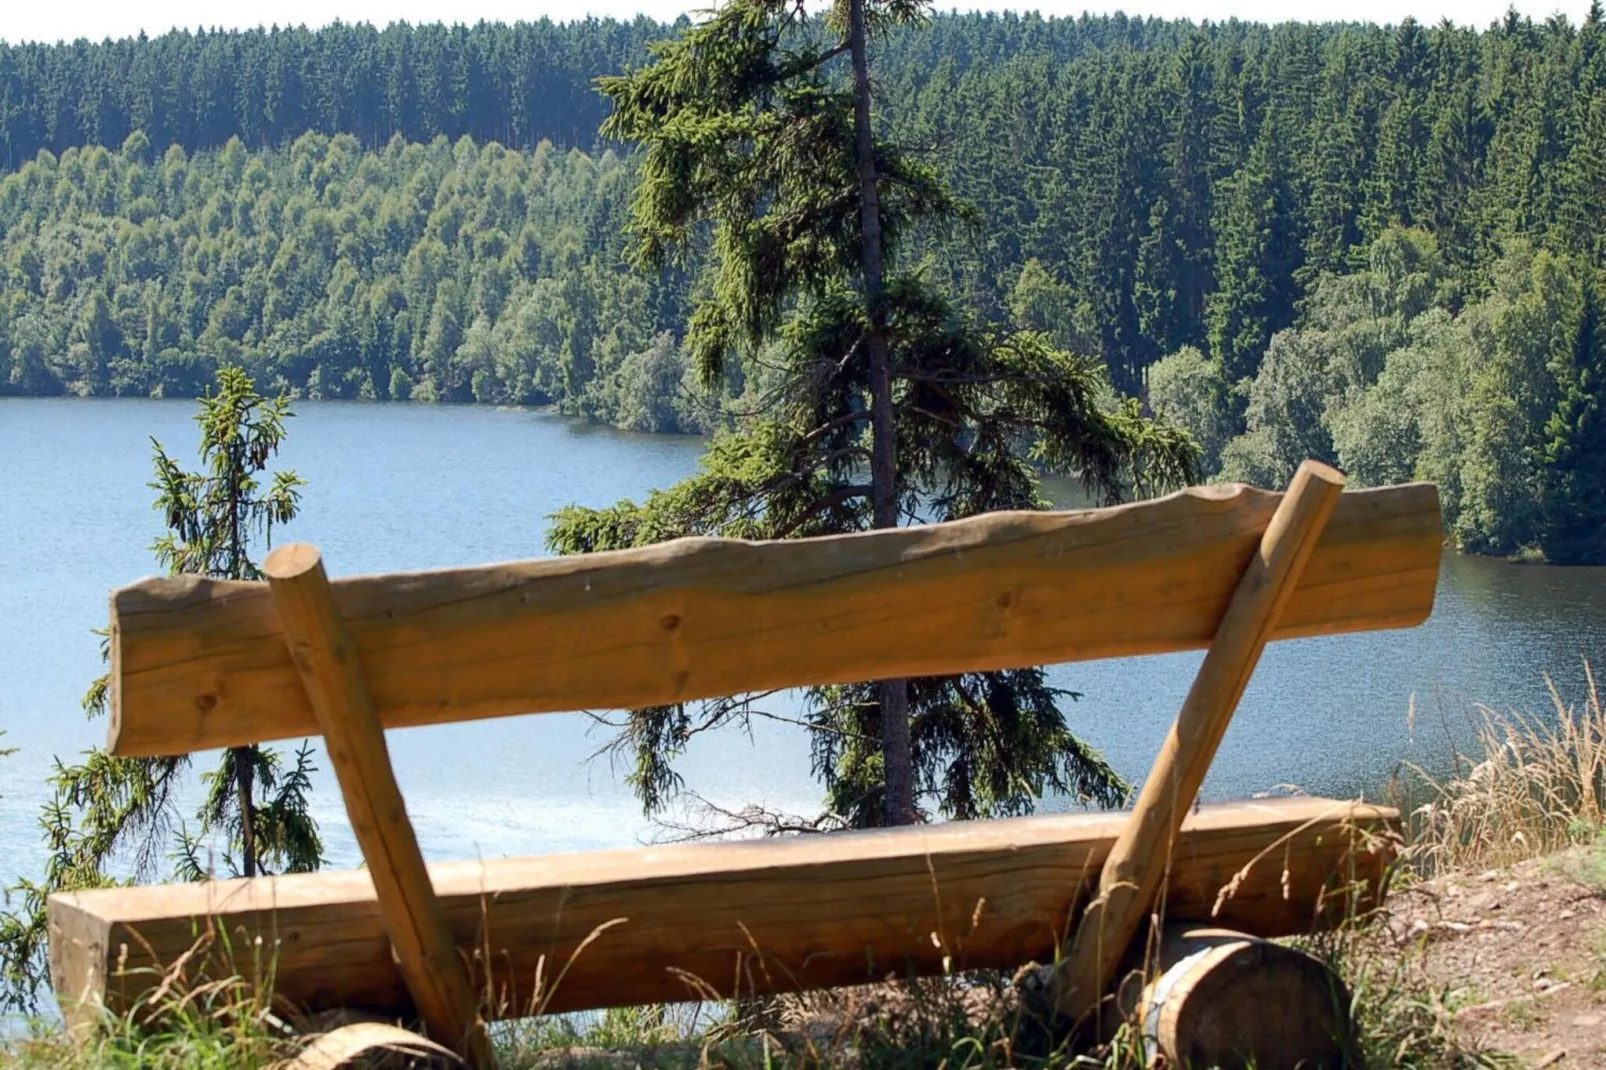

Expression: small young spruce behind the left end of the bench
xmin=0 ymin=368 xmax=323 ymax=1007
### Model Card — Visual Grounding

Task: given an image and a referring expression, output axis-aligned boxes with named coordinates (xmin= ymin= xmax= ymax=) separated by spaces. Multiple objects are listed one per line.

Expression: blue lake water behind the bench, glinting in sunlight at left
xmin=0 ymin=398 xmax=1606 ymax=884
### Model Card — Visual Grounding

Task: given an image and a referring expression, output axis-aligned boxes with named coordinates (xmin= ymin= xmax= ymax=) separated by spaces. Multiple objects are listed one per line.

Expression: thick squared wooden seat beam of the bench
xmin=50 ymin=798 xmax=1399 ymax=1017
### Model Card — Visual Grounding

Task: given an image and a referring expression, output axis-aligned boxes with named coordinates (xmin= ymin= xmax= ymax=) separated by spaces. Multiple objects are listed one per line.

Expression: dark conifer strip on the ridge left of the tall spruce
xmin=0 ymin=18 xmax=668 ymax=167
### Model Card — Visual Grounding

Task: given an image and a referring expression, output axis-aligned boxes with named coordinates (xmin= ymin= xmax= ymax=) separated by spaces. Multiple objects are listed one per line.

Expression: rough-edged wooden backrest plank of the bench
xmin=109 ymin=484 xmax=1442 ymax=755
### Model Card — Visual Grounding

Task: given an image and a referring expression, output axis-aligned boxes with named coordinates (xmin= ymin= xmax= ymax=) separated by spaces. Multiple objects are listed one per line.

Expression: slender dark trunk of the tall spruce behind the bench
xmin=848 ymin=0 xmax=917 ymax=824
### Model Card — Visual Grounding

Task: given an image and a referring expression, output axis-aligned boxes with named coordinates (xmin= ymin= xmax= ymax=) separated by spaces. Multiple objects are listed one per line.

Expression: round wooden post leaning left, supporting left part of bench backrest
xmin=263 ymin=543 xmax=495 ymax=1067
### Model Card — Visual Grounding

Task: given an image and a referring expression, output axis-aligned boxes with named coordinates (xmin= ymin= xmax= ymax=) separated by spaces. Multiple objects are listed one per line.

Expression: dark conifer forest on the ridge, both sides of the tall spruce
xmin=9 ymin=13 xmax=1606 ymax=383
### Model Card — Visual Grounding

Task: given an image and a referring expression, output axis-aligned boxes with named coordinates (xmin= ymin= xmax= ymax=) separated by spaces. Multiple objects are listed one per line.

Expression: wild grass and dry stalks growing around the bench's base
xmin=0 ymin=675 xmax=1606 ymax=1070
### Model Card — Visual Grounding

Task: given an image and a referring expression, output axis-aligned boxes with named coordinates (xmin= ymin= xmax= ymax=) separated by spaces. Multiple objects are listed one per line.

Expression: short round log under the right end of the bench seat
xmin=1132 ymin=925 xmax=1354 ymax=1070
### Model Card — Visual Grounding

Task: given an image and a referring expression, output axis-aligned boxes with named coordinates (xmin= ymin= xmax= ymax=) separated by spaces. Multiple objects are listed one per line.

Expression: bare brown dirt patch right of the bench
xmin=1388 ymin=847 xmax=1606 ymax=1070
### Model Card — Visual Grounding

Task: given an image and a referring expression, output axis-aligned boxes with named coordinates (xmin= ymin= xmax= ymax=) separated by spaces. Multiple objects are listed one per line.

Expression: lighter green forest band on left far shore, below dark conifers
xmin=0 ymin=133 xmax=697 ymax=431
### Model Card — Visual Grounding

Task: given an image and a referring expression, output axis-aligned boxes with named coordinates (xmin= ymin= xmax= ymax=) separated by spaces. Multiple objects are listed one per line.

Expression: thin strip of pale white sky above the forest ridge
xmin=0 ymin=0 xmax=1590 ymax=42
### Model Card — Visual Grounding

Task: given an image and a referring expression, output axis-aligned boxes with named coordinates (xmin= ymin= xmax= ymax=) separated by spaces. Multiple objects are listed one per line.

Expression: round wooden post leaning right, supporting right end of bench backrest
xmin=1055 ymin=461 xmax=1344 ymax=1022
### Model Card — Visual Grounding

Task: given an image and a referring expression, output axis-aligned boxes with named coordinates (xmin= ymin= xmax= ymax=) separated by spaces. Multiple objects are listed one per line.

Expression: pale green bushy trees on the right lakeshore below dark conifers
xmin=1169 ymin=228 xmax=1606 ymax=564
